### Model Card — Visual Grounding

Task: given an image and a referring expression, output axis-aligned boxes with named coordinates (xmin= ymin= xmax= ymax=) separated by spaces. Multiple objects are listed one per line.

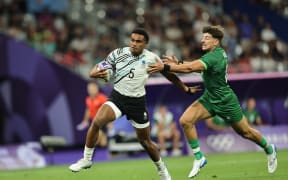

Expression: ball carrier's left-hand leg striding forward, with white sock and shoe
xmin=69 ymin=104 xmax=115 ymax=172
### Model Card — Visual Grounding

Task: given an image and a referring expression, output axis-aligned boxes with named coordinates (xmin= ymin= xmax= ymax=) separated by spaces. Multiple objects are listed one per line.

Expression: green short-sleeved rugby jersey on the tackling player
xmin=200 ymin=45 xmax=233 ymax=103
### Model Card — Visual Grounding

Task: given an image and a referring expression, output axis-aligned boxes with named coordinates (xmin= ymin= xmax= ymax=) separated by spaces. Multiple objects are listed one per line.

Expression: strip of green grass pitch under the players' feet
xmin=0 ymin=150 xmax=288 ymax=180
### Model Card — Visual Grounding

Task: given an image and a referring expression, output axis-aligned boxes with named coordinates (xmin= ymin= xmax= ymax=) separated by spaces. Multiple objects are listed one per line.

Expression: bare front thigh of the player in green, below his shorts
xmin=180 ymin=101 xmax=211 ymax=123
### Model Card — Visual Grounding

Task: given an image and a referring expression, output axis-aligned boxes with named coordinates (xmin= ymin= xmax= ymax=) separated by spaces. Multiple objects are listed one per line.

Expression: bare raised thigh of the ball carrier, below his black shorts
xmin=93 ymin=104 xmax=116 ymax=127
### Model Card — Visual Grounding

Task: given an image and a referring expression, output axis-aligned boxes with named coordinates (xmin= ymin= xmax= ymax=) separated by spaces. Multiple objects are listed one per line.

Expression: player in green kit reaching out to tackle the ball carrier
xmin=148 ymin=26 xmax=277 ymax=178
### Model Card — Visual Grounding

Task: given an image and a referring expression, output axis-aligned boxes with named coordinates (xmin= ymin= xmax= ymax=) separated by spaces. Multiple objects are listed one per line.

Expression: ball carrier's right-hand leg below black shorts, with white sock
xmin=135 ymin=126 xmax=171 ymax=180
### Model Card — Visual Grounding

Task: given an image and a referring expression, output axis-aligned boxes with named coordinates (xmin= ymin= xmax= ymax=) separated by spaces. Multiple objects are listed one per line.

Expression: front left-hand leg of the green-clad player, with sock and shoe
xmin=180 ymin=101 xmax=211 ymax=178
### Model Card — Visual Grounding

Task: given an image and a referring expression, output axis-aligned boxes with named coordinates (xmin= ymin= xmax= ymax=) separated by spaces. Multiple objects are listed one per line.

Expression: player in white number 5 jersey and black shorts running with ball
xmin=69 ymin=28 xmax=201 ymax=180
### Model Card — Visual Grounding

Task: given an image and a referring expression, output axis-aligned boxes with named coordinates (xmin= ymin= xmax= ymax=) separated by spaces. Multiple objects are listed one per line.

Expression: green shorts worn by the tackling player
xmin=198 ymin=93 xmax=243 ymax=124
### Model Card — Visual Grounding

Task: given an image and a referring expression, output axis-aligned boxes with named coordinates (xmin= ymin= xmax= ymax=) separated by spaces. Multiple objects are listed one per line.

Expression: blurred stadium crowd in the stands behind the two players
xmin=0 ymin=0 xmax=288 ymax=78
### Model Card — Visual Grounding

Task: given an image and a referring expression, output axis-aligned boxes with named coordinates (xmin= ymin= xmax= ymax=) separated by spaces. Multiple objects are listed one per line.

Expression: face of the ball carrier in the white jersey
xmin=130 ymin=33 xmax=147 ymax=56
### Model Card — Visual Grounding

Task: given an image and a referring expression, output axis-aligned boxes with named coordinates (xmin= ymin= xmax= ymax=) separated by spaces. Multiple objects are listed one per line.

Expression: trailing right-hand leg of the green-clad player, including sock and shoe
xmin=232 ymin=116 xmax=277 ymax=173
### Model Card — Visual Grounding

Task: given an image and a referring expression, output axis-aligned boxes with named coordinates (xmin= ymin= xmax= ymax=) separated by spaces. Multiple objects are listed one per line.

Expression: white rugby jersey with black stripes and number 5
xmin=105 ymin=47 xmax=161 ymax=97
